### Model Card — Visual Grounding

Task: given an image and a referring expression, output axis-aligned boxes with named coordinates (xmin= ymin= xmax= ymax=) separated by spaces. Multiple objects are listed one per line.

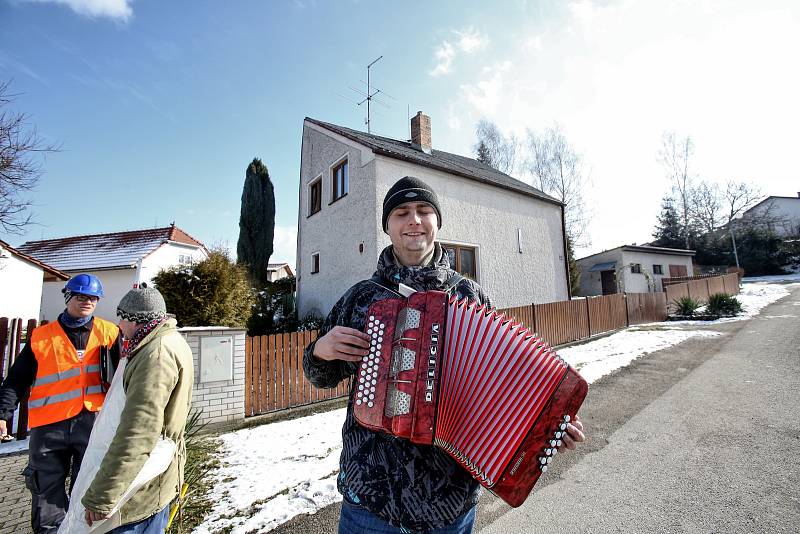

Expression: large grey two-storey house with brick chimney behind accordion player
xmin=296 ymin=112 xmax=570 ymax=317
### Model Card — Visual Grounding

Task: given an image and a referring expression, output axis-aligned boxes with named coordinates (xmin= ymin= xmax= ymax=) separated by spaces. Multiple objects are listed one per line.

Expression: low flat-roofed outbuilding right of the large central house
xmin=576 ymin=245 xmax=695 ymax=296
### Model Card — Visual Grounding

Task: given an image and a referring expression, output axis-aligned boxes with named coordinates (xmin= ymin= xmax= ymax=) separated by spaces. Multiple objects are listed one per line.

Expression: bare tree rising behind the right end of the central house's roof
xmin=525 ymin=125 xmax=590 ymax=247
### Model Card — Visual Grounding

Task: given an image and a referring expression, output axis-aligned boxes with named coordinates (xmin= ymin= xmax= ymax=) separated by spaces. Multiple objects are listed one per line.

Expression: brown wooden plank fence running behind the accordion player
xmin=245 ymin=273 xmax=739 ymax=416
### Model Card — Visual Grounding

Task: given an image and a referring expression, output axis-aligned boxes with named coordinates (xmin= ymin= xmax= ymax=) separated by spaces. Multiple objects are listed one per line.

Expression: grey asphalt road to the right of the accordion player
xmin=273 ymin=285 xmax=800 ymax=534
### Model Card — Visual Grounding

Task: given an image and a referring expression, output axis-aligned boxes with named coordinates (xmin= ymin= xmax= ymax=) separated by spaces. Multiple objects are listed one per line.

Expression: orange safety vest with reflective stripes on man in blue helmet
xmin=28 ymin=317 xmax=119 ymax=428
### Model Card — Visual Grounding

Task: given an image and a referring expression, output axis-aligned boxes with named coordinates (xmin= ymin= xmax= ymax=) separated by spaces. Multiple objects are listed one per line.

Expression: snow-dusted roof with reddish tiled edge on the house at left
xmin=19 ymin=224 xmax=206 ymax=271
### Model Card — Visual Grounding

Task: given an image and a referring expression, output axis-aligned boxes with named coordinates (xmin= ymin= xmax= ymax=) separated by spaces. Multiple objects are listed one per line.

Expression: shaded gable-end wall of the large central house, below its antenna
xmin=295 ymin=123 xmax=383 ymax=318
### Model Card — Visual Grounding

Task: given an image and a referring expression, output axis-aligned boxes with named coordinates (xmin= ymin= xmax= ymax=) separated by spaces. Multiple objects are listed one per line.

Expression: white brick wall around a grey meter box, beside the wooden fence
xmin=179 ymin=327 xmax=245 ymax=425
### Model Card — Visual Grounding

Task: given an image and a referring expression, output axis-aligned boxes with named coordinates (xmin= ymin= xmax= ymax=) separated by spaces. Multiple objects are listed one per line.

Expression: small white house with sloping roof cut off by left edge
xmin=0 ymin=240 xmax=69 ymax=320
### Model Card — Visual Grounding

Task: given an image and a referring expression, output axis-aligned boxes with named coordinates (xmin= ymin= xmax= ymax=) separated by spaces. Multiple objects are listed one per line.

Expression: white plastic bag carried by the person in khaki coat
xmin=58 ymin=358 xmax=176 ymax=534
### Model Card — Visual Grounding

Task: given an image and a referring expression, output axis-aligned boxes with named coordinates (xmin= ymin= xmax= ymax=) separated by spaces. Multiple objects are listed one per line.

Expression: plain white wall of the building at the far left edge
xmin=0 ymin=255 xmax=43 ymax=320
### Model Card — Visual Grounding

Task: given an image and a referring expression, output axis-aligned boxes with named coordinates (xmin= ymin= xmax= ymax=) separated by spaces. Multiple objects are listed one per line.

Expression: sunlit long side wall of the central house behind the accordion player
xmin=374 ymin=156 xmax=569 ymax=308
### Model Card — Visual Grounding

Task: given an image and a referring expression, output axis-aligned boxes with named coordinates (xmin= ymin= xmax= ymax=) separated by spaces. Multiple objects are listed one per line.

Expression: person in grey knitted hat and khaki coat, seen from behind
xmin=80 ymin=287 xmax=194 ymax=534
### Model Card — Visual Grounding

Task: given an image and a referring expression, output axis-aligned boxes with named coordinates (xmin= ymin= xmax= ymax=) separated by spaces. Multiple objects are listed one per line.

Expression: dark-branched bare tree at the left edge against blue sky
xmin=0 ymin=82 xmax=58 ymax=233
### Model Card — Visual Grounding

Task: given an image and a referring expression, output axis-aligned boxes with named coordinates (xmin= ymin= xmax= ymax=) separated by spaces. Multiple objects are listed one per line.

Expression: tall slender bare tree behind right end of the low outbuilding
xmin=658 ymin=132 xmax=694 ymax=249
